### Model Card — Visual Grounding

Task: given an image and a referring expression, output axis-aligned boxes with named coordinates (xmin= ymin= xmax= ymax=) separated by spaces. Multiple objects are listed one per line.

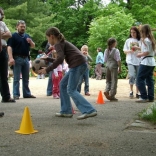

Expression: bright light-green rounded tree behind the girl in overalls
xmin=88 ymin=4 xmax=135 ymax=58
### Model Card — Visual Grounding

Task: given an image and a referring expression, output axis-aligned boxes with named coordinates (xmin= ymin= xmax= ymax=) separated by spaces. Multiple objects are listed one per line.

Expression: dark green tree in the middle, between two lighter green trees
xmin=48 ymin=0 xmax=100 ymax=48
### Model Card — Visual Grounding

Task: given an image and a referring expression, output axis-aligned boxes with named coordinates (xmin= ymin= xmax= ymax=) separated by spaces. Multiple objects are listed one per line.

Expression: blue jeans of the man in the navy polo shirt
xmin=13 ymin=56 xmax=31 ymax=97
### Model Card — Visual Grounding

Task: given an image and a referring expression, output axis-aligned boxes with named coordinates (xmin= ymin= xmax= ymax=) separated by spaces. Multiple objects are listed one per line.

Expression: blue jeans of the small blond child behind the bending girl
xmin=77 ymin=68 xmax=89 ymax=94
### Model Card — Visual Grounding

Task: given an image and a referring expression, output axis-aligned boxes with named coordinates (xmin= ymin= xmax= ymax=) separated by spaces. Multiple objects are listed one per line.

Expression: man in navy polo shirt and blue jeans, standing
xmin=8 ymin=20 xmax=36 ymax=100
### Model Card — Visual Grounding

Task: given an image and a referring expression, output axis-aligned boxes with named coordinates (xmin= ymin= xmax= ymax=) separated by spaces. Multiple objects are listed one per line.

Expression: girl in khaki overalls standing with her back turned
xmin=104 ymin=38 xmax=121 ymax=101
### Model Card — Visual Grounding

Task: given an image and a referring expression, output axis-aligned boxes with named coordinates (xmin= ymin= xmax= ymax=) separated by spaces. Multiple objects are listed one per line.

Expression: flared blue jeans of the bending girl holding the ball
xmin=60 ymin=63 xmax=96 ymax=114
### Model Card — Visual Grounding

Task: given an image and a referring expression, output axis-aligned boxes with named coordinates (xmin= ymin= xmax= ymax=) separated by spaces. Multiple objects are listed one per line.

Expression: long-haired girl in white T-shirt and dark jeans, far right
xmin=133 ymin=24 xmax=156 ymax=103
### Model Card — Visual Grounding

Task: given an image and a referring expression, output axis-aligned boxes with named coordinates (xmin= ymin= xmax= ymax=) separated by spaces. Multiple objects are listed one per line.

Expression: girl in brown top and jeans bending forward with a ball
xmin=39 ymin=27 xmax=97 ymax=120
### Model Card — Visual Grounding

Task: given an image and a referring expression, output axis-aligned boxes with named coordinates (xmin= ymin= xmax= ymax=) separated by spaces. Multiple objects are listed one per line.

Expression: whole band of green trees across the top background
xmin=0 ymin=0 xmax=156 ymax=66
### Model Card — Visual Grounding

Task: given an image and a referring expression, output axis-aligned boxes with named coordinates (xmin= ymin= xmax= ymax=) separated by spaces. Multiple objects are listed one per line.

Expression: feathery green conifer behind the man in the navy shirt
xmin=2 ymin=0 xmax=56 ymax=57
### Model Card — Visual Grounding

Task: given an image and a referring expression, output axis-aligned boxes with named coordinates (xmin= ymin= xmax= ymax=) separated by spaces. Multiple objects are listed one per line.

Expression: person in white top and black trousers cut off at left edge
xmin=0 ymin=8 xmax=15 ymax=105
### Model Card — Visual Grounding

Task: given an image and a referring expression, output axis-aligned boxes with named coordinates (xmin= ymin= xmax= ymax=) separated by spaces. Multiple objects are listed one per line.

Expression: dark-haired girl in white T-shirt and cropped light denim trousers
xmin=123 ymin=26 xmax=140 ymax=98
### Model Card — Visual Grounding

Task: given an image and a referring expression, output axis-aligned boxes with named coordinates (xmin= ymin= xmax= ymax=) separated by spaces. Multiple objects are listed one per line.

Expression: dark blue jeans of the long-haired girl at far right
xmin=137 ymin=65 xmax=154 ymax=100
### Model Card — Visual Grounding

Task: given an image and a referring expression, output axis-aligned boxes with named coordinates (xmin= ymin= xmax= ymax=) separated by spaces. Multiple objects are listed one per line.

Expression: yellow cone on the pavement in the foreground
xmin=15 ymin=107 xmax=38 ymax=134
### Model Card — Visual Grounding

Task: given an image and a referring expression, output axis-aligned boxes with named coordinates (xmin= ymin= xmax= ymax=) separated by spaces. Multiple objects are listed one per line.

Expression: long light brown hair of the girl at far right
xmin=140 ymin=24 xmax=156 ymax=50
